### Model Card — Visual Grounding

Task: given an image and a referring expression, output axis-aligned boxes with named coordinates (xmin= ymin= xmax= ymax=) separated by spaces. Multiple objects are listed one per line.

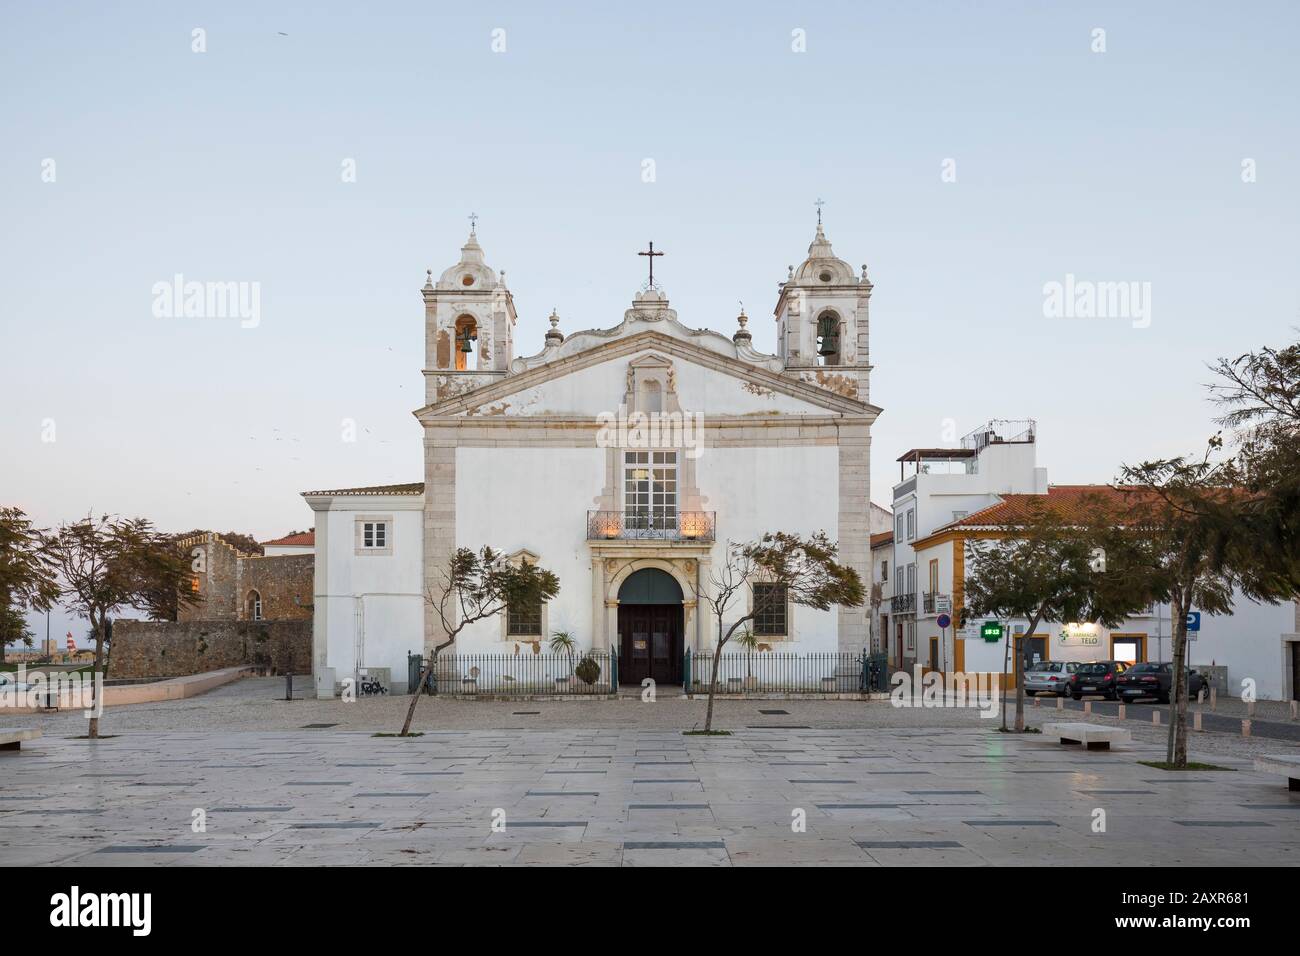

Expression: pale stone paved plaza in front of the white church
xmin=0 ymin=682 xmax=1300 ymax=866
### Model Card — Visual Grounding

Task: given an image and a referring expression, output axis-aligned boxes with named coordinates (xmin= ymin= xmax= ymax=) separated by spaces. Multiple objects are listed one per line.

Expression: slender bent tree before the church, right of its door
xmin=697 ymin=531 xmax=865 ymax=734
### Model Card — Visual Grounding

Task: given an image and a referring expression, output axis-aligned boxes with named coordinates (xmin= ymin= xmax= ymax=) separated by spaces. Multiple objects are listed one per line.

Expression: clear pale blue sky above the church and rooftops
xmin=0 ymin=0 xmax=1300 ymax=636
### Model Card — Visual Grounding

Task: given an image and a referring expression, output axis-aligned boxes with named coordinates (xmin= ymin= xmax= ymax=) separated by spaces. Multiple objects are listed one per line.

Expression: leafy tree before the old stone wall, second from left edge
xmin=46 ymin=515 xmax=192 ymax=737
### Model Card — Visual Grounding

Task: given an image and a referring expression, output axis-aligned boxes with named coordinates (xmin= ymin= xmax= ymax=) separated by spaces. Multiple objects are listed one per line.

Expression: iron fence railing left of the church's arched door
xmin=408 ymin=645 xmax=619 ymax=697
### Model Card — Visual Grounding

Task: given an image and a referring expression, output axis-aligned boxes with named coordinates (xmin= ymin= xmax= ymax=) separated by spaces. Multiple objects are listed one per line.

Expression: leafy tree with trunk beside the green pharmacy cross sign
xmin=962 ymin=494 xmax=1147 ymax=732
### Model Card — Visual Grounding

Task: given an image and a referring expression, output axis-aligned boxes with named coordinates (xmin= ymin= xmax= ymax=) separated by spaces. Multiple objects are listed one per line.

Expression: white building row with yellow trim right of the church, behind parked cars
xmin=891 ymin=423 xmax=1300 ymax=700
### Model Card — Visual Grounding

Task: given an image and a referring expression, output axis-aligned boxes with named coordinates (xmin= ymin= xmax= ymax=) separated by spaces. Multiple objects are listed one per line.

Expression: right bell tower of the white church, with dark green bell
xmin=776 ymin=218 xmax=872 ymax=402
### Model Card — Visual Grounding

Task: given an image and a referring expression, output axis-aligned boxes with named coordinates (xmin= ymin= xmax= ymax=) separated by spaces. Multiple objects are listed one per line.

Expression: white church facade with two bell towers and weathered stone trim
xmin=304 ymin=222 xmax=880 ymax=693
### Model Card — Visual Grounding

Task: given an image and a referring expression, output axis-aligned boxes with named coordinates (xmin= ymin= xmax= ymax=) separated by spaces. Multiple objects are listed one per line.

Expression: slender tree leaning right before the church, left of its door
xmin=400 ymin=546 xmax=560 ymax=736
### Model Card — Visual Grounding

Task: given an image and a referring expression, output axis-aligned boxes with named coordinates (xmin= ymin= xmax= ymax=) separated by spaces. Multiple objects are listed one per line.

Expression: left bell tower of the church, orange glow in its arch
xmin=420 ymin=216 xmax=516 ymax=403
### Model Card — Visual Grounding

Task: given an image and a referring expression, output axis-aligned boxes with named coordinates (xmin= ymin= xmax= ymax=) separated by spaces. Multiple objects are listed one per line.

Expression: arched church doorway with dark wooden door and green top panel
xmin=619 ymin=567 xmax=683 ymax=684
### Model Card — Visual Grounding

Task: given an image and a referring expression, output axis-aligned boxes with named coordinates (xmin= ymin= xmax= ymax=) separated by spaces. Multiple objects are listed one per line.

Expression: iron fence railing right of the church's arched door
xmin=683 ymin=650 xmax=888 ymax=695
